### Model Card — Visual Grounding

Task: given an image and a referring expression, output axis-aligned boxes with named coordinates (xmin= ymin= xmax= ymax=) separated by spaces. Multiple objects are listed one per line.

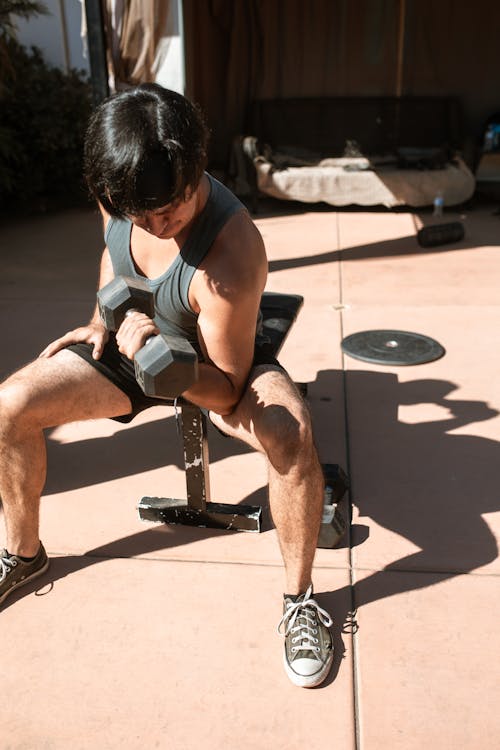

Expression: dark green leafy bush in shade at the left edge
xmin=0 ymin=39 xmax=91 ymax=211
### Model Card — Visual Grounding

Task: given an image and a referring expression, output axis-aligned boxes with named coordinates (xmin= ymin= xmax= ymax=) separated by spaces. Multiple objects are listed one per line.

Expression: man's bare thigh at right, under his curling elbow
xmin=210 ymin=365 xmax=308 ymax=451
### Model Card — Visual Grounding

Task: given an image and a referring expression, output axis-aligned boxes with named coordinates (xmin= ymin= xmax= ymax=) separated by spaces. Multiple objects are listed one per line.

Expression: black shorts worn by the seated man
xmin=68 ymin=333 xmax=284 ymax=422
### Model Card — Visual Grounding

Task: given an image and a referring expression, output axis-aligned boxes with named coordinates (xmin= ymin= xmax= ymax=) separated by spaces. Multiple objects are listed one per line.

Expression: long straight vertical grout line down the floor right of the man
xmin=335 ymin=211 xmax=361 ymax=750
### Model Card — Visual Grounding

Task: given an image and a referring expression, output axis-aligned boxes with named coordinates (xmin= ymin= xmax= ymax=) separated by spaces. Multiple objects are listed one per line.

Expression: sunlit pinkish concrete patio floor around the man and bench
xmin=0 ymin=195 xmax=500 ymax=750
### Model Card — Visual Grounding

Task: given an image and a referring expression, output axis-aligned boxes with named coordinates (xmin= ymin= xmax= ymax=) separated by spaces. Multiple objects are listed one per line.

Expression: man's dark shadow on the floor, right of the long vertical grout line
xmin=318 ymin=370 xmax=500 ymax=636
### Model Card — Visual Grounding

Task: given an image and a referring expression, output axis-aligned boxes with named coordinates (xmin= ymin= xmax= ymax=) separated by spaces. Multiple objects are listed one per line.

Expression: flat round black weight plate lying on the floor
xmin=341 ymin=331 xmax=445 ymax=365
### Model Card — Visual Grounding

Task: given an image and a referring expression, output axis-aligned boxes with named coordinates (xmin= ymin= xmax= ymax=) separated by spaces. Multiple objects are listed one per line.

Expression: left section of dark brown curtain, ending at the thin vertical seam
xmin=184 ymin=0 xmax=399 ymax=164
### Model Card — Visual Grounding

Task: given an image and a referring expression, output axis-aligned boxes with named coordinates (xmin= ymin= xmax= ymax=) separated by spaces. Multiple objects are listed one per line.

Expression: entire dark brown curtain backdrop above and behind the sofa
xmin=184 ymin=0 xmax=500 ymax=165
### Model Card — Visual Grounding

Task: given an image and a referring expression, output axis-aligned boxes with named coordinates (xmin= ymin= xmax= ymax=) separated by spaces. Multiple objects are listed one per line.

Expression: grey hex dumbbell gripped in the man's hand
xmin=97 ymin=276 xmax=198 ymax=398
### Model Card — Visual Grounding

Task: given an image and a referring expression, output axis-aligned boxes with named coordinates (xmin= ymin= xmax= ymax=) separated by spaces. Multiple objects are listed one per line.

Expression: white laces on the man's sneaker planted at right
xmin=278 ymin=586 xmax=333 ymax=654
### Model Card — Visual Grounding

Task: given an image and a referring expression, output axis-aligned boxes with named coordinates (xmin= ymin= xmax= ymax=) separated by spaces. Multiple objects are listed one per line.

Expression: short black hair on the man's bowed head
xmin=84 ymin=83 xmax=208 ymax=217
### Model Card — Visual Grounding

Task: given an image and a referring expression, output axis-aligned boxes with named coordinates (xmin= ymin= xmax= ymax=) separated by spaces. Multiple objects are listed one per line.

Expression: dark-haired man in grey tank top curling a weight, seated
xmin=0 ymin=84 xmax=333 ymax=687
